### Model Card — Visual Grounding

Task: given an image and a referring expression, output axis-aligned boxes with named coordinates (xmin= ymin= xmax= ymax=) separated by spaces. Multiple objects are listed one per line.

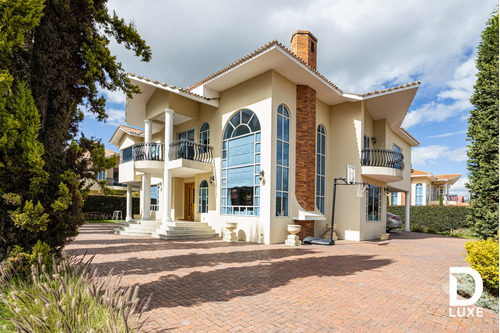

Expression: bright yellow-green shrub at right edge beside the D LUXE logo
xmin=465 ymin=238 xmax=499 ymax=295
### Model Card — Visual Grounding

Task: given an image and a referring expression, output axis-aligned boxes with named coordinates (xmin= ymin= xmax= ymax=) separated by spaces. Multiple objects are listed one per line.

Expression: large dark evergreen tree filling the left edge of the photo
xmin=0 ymin=0 xmax=151 ymax=261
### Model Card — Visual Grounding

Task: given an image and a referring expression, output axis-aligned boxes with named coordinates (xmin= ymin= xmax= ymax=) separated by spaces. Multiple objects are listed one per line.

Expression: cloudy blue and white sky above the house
xmin=80 ymin=0 xmax=498 ymax=195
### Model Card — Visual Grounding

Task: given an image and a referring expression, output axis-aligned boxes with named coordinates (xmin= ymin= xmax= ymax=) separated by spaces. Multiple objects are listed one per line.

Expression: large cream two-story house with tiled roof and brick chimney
xmin=110 ymin=31 xmax=420 ymax=244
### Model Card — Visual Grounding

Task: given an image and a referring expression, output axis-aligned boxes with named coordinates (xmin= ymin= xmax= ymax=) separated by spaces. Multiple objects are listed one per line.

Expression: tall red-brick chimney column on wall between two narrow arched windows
xmin=295 ymin=85 xmax=316 ymax=211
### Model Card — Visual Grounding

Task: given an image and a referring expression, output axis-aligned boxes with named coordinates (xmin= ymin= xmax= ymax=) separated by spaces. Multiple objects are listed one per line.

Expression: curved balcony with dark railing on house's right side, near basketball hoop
xmin=361 ymin=148 xmax=405 ymax=183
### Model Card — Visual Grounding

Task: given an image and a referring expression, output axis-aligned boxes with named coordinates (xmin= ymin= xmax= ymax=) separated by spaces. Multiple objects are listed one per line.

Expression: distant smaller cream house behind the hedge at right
xmin=390 ymin=169 xmax=463 ymax=206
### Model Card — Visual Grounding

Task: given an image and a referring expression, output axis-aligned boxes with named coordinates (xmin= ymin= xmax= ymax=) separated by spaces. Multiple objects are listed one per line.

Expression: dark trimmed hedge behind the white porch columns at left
xmin=82 ymin=195 xmax=140 ymax=218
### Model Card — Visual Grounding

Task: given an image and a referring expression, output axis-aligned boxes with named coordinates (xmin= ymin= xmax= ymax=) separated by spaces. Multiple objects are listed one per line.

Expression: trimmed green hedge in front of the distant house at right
xmin=387 ymin=206 xmax=469 ymax=232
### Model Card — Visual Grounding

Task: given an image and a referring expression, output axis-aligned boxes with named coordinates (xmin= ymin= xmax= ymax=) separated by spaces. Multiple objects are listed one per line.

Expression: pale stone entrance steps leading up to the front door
xmin=114 ymin=220 xmax=219 ymax=239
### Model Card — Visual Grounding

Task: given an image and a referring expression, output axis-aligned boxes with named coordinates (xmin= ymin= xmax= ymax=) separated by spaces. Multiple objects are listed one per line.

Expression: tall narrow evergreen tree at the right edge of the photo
xmin=467 ymin=10 xmax=499 ymax=238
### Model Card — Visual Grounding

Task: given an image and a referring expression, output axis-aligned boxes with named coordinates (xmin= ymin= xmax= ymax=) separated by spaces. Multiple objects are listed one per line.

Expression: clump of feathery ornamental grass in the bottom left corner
xmin=0 ymin=254 xmax=149 ymax=332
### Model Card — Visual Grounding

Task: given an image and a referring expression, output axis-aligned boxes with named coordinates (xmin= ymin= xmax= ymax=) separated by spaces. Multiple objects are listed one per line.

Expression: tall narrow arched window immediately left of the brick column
xmin=276 ymin=105 xmax=290 ymax=216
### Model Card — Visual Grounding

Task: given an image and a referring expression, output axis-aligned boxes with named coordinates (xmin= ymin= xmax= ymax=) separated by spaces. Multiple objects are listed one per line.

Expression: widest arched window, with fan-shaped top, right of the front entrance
xmin=221 ymin=109 xmax=260 ymax=215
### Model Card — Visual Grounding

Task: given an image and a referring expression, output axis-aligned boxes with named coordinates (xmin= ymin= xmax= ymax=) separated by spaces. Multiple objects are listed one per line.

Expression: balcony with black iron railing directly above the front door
xmin=168 ymin=140 xmax=214 ymax=178
